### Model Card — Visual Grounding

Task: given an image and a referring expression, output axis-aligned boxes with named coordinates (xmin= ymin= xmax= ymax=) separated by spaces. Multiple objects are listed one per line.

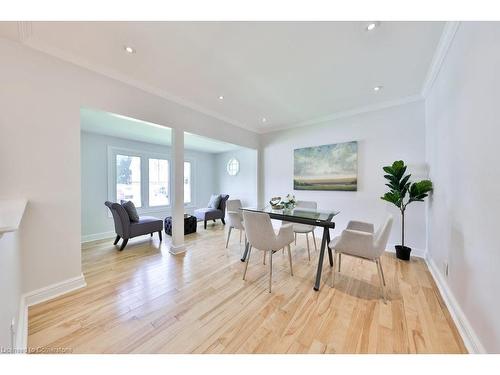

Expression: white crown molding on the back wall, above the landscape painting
xmin=260 ymin=94 xmax=424 ymax=134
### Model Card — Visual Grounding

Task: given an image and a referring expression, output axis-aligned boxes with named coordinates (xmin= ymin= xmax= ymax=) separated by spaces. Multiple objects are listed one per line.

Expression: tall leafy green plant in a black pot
xmin=381 ymin=160 xmax=432 ymax=260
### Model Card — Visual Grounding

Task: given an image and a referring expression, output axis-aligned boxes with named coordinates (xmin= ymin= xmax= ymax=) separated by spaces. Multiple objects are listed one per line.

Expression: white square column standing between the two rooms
xmin=169 ymin=128 xmax=186 ymax=254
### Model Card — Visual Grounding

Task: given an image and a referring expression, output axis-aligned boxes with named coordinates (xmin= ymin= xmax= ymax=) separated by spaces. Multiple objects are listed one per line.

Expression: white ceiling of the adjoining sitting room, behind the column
xmin=80 ymin=108 xmax=242 ymax=154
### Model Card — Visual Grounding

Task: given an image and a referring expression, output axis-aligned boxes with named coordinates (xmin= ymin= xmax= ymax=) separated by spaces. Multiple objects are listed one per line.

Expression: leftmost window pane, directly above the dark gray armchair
xmin=116 ymin=155 xmax=141 ymax=207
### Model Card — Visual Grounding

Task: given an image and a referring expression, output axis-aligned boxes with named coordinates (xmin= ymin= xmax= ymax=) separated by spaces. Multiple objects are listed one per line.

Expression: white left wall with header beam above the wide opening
xmin=0 ymin=39 xmax=259 ymax=291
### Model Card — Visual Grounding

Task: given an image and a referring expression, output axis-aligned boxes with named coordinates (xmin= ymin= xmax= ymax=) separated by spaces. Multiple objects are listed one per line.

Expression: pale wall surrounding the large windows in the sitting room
xmin=81 ymin=132 xmax=217 ymax=241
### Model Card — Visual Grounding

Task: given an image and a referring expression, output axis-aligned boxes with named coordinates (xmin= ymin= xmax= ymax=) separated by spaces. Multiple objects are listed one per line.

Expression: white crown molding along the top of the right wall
xmin=421 ymin=21 xmax=460 ymax=98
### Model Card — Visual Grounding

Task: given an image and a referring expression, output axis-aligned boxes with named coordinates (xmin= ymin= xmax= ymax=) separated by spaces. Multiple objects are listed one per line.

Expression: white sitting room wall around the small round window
xmin=216 ymin=148 xmax=257 ymax=207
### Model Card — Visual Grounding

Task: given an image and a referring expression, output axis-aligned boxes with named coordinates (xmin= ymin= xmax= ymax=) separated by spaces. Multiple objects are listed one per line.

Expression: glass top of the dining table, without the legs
xmin=242 ymin=205 xmax=339 ymax=223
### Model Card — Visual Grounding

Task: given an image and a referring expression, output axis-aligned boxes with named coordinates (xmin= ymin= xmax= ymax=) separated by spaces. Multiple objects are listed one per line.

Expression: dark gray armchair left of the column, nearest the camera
xmin=104 ymin=201 xmax=163 ymax=251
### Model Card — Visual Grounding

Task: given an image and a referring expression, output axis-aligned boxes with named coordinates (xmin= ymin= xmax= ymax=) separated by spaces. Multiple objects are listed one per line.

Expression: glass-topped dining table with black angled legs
xmin=241 ymin=206 xmax=339 ymax=291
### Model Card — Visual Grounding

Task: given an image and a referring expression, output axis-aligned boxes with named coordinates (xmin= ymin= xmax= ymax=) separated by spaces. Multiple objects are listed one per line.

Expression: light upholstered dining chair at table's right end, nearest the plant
xmin=328 ymin=215 xmax=393 ymax=302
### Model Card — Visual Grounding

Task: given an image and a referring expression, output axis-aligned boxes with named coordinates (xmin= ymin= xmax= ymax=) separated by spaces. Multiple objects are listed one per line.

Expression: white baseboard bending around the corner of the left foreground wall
xmin=15 ymin=274 xmax=87 ymax=353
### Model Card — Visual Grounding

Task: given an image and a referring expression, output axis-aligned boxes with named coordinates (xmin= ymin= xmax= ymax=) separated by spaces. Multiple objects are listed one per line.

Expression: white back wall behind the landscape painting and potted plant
xmin=262 ymin=101 xmax=426 ymax=254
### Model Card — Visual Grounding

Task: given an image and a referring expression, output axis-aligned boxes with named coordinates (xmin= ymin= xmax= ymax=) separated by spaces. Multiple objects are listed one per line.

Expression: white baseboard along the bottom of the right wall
xmin=425 ymin=256 xmax=487 ymax=354
